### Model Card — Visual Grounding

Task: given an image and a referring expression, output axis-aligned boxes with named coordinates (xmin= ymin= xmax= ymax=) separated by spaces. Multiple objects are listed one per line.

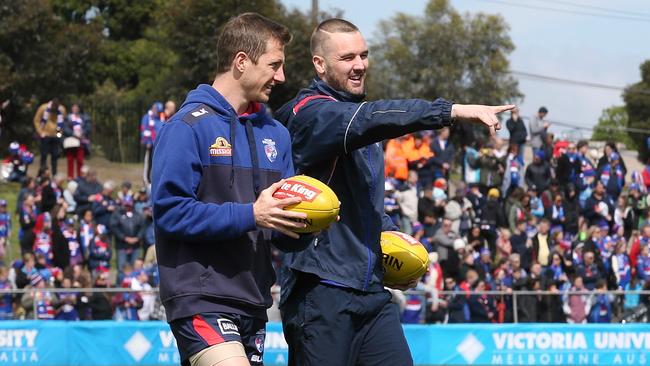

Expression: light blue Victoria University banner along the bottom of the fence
xmin=0 ymin=321 xmax=650 ymax=366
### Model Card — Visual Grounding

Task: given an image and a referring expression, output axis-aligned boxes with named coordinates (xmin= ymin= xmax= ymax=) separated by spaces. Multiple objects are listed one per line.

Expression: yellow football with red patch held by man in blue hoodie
xmin=273 ymin=175 xmax=341 ymax=233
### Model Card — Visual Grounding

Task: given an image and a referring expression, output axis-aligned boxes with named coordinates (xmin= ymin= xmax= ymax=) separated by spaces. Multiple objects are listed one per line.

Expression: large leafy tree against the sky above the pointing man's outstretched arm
xmin=369 ymin=0 xmax=522 ymax=104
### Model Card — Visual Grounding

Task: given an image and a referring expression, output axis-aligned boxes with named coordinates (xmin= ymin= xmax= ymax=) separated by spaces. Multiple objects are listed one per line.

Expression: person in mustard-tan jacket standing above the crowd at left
xmin=34 ymin=98 xmax=66 ymax=176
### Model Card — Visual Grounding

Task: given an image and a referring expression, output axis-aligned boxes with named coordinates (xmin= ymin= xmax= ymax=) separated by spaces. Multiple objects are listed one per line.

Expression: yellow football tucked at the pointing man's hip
xmin=380 ymin=231 xmax=429 ymax=285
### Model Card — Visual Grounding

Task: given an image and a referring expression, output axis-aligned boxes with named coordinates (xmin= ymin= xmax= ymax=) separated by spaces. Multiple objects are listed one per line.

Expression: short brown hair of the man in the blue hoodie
xmin=217 ymin=13 xmax=291 ymax=74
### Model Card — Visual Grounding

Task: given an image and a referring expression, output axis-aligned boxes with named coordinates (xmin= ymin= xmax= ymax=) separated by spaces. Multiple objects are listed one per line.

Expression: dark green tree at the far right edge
xmin=623 ymin=60 xmax=650 ymax=162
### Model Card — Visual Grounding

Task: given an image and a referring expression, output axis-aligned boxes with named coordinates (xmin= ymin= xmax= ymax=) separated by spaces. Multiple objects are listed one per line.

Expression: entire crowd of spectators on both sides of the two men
xmin=0 ymin=104 xmax=650 ymax=323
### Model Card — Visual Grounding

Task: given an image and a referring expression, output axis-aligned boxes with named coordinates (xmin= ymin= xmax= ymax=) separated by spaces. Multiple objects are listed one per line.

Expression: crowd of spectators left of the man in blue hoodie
xmin=0 ymin=99 xmax=170 ymax=320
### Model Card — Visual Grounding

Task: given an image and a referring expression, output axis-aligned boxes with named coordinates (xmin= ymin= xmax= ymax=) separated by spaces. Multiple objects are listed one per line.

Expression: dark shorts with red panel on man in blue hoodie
xmin=169 ymin=313 xmax=266 ymax=365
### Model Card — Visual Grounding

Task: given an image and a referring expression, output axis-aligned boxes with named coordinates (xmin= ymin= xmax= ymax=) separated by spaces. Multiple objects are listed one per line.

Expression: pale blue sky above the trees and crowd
xmin=282 ymin=0 xmax=650 ymax=137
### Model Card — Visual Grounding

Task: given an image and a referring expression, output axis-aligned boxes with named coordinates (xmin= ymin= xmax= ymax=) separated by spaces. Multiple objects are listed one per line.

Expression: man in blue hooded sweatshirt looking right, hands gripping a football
xmin=152 ymin=13 xmax=311 ymax=366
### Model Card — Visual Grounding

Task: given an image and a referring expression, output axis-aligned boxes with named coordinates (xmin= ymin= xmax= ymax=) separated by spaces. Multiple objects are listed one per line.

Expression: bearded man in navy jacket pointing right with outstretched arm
xmin=276 ymin=19 xmax=513 ymax=366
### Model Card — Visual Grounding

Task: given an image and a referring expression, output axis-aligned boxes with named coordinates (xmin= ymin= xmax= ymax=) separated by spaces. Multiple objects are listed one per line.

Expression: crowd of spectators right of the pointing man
xmin=384 ymin=108 xmax=650 ymax=323
